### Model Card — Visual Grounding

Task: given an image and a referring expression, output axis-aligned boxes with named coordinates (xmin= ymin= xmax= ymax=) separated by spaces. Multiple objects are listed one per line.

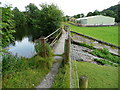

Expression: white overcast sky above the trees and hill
xmin=0 ymin=0 xmax=119 ymax=16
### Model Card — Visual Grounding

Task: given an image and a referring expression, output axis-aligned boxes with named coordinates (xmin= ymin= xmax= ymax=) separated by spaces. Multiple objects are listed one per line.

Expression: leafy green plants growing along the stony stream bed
xmin=74 ymin=42 xmax=120 ymax=66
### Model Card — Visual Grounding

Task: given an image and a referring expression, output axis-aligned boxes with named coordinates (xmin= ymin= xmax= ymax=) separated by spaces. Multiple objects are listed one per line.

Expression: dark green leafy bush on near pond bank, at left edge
xmin=2 ymin=54 xmax=28 ymax=76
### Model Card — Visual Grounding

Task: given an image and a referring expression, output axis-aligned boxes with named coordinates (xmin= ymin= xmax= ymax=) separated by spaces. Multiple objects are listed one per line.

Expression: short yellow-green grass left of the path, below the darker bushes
xmin=3 ymin=69 xmax=49 ymax=88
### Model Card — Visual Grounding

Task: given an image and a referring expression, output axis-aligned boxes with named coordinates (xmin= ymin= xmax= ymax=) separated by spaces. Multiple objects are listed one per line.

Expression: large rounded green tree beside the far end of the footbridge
xmin=39 ymin=4 xmax=63 ymax=35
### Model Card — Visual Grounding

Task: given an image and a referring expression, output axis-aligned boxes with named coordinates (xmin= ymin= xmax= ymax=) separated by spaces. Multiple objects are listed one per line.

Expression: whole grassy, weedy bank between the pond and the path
xmin=2 ymin=54 xmax=52 ymax=88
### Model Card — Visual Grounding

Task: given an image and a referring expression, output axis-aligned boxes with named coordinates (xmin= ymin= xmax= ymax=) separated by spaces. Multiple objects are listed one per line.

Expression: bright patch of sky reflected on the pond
xmin=8 ymin=37 xmax=36 ymax=58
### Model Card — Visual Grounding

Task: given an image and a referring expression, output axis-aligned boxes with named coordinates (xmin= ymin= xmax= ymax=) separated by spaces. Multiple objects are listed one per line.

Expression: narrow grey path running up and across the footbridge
xmin=36 ymin=30 xmax=68 ymax=89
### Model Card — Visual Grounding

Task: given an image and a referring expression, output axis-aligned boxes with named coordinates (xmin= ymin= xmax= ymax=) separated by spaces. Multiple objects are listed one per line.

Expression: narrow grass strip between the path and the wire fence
xmin=52 ymin=64 xmax=70 ymax=88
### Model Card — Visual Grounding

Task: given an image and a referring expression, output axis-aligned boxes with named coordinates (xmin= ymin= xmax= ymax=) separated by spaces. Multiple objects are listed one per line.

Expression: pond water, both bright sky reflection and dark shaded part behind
xmin=7 ymin=27 xmax=42 ymax=58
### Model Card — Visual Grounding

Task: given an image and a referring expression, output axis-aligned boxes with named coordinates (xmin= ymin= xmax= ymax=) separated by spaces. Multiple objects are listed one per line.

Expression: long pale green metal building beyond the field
xmin=75 ymin=15 xmax=115 ymax=25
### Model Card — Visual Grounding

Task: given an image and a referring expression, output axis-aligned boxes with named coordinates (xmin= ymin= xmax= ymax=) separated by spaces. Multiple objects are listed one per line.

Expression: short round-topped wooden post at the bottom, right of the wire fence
xmin=79 ymin=75 xmax=88 ymax=90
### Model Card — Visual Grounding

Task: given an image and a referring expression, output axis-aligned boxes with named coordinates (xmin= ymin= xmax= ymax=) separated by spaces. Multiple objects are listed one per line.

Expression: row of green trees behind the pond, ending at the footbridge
xmin=12 ymin=3 xmax=63 ymax=36
